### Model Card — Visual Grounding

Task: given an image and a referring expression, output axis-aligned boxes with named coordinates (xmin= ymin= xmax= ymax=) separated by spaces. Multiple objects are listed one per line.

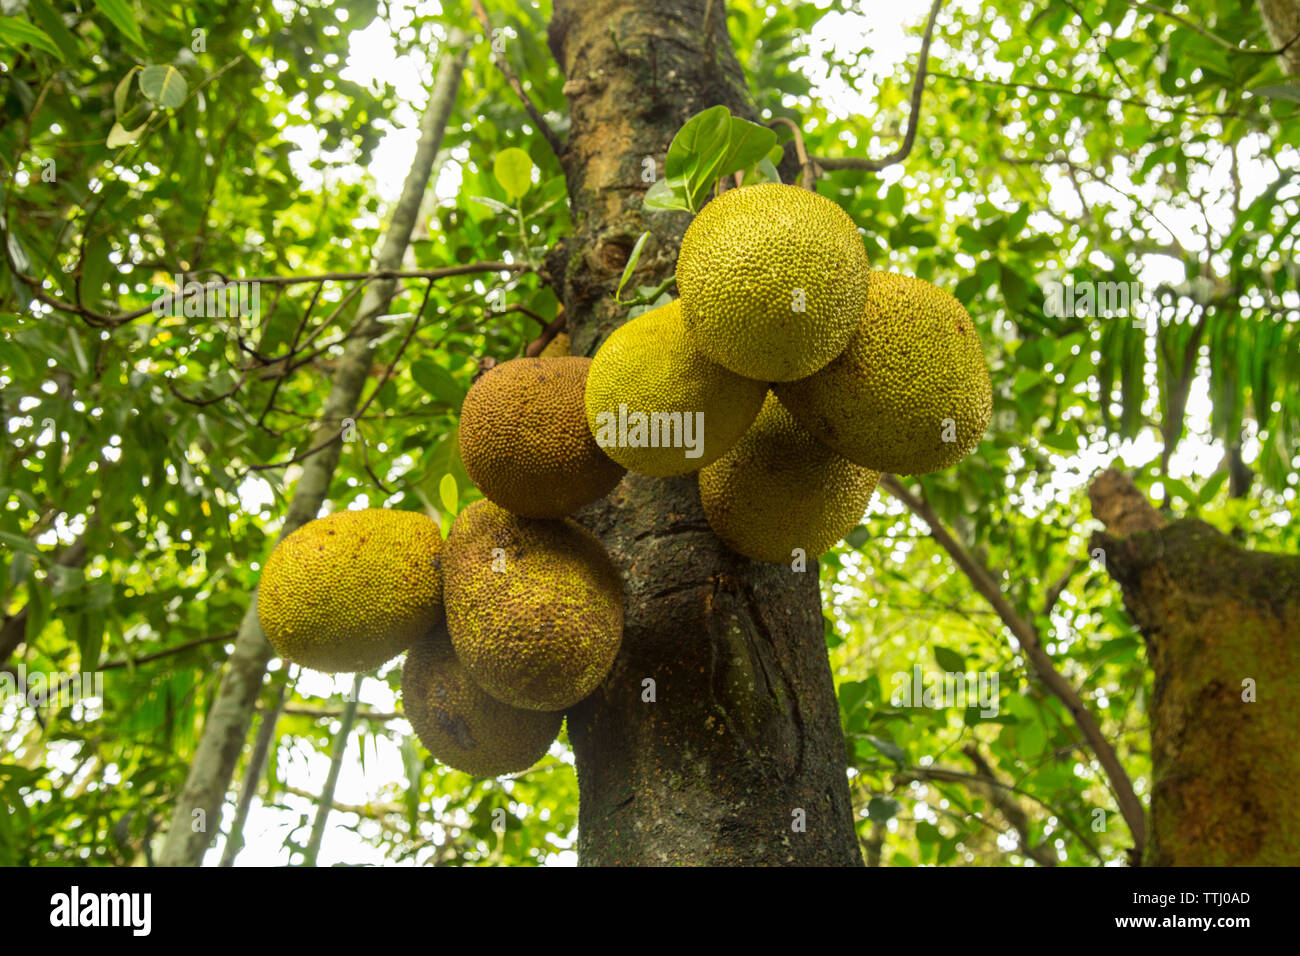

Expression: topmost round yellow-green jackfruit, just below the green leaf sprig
xmin=677 ymin=182 xmax=870 ymax=381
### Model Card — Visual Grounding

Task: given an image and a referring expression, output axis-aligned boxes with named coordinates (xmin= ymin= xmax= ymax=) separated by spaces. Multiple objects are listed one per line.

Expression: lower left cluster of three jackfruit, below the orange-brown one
xmin=257 ymin=463 xmax=623 ymax=777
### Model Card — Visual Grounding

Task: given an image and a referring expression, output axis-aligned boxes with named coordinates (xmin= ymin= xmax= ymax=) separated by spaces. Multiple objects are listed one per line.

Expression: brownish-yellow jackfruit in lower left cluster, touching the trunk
xmin=443 ymin=501 xmax=623 ymax=710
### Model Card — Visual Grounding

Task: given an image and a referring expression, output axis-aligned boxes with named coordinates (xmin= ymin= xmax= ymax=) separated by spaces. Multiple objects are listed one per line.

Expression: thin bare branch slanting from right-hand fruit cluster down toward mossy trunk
xmin=880 ymin=475 xmax=1147 ymax=858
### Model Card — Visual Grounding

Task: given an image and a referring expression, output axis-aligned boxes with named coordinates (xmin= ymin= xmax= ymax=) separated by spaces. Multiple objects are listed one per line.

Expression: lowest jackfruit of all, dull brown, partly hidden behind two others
xmin=402 ymin=622 xmax=564 ymax=777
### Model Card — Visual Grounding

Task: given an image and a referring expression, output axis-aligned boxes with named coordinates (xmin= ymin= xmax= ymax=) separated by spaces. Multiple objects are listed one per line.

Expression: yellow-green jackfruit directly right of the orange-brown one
xmin=586 ymin=300 xmax=767 ymax=477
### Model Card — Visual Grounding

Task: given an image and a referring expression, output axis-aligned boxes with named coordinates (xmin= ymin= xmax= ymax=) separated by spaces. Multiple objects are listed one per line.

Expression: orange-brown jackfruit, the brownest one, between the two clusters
xmin=460 ymin=356 xmax=624 ymax=518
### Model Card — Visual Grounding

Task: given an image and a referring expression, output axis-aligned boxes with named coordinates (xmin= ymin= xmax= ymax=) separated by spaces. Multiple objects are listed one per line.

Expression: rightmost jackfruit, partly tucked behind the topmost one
xmin=775 ymin=272 xmax=993 ymax=475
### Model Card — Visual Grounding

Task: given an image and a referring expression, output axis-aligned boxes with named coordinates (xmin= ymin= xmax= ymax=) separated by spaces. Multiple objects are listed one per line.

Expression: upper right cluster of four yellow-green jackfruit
xmin=586 ymin=183 xmax=993 ymax=562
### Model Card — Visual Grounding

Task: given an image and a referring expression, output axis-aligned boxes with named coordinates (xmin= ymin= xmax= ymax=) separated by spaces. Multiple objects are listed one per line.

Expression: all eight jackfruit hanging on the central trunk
xmin=259 ymin=183 xmax=992 ymax=777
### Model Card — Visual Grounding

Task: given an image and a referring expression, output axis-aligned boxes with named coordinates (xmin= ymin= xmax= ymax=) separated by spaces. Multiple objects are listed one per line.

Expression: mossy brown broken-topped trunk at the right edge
xmin=1089 ymin=471 xmax=1300 ymax=866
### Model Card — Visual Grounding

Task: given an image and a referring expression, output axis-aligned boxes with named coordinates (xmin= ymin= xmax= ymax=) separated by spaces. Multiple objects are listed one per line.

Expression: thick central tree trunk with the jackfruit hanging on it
xmin=547 ymin=0 xmax=862 ymax=865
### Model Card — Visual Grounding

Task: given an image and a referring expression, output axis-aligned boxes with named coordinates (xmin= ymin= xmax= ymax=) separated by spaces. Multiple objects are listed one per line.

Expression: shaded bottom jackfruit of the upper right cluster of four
xmin=699 ymin=395 xmax=880 ymax=563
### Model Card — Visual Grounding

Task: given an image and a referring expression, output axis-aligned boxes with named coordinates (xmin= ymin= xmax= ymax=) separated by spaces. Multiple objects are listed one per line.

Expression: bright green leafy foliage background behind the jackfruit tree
xmin=0 ymin=0 xmax=1300 ymax=865
